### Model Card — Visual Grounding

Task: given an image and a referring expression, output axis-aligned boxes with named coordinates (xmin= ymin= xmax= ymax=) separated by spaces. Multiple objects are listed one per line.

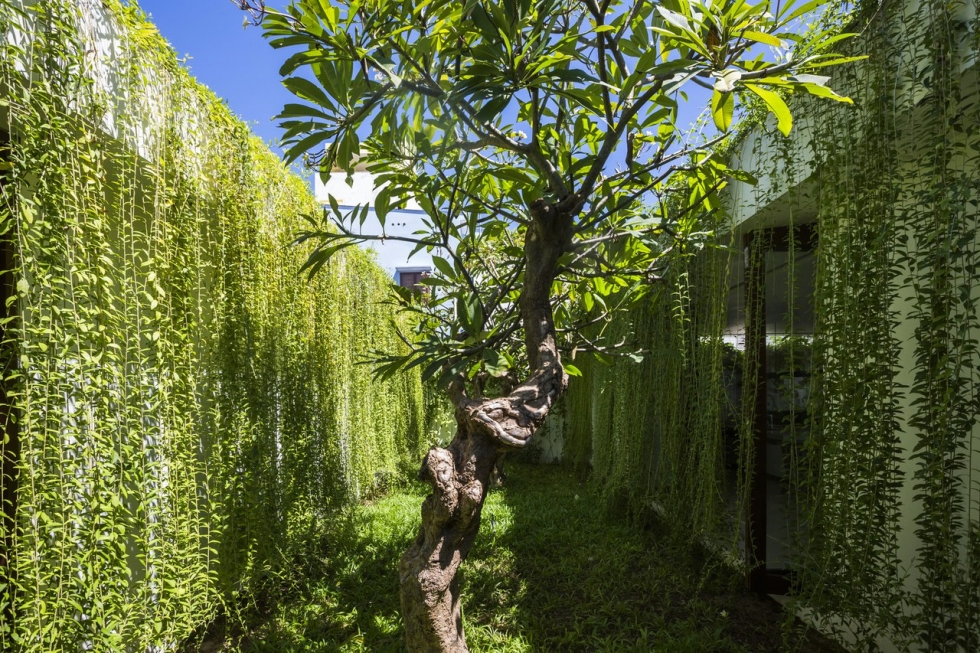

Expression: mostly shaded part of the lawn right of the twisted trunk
xmin=464 ymin=467 xmax=745 ymax=652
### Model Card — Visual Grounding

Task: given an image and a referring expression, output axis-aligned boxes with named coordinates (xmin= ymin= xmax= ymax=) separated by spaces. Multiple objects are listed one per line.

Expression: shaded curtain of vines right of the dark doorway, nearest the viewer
xmin=788 ymin=1 xmax=980 ymax=651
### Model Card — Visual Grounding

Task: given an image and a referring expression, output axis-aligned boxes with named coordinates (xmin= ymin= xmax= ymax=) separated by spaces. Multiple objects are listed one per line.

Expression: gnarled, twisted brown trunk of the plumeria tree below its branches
xmin=398 ymin=196 xmax=579 ymax=653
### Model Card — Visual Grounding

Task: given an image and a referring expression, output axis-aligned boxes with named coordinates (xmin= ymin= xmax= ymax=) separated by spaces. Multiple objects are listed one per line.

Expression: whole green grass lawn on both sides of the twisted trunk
xmin=200 ymin=465 xmax=839 ymax=653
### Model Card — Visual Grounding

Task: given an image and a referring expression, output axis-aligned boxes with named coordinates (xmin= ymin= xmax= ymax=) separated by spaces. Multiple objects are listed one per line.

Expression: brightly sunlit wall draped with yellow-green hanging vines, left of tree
xmin=0 ymin=0 xmax=431 ymax=652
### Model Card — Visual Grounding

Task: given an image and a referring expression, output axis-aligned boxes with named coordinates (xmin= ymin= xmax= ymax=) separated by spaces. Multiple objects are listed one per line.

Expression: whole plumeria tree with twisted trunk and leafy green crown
xmin=233 ymin=0 xmax=846 ymax=652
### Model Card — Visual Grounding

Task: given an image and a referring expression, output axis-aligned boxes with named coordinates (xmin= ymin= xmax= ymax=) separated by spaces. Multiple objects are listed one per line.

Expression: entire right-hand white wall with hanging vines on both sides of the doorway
xmin=565 ymin=0 xmax=980 ymax=651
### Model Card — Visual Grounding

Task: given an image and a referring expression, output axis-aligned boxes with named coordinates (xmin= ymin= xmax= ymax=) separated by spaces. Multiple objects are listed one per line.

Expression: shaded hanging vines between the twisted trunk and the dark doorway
xmin=563 ymin=244 xmax=729 ymax=533
